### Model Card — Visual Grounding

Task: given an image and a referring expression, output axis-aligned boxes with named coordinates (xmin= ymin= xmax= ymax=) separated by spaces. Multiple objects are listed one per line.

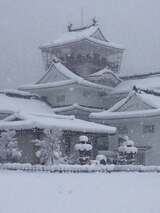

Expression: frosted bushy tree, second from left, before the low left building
xmin=33 ymin=128 xmax=63 ymax=165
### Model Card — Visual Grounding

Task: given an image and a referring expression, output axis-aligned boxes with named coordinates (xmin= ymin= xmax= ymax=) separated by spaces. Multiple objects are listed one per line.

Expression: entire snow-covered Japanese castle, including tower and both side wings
xmin=0 ymin=19 xmax=160 ymax=165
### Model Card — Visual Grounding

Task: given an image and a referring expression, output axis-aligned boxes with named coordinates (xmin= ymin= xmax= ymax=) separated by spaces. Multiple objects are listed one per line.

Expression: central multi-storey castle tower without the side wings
xmin=20 ymin=20 xmax=124 ymax=120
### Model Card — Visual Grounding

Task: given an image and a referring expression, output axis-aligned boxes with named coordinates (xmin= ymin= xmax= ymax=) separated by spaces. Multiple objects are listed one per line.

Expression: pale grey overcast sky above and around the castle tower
xmin=0 ymin=0 xmax=160 ymax=88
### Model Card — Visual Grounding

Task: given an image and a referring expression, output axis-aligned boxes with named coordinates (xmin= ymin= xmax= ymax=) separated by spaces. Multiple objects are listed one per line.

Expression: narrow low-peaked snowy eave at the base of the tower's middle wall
xmin=53 ymin=103 xmax=102 ymax=113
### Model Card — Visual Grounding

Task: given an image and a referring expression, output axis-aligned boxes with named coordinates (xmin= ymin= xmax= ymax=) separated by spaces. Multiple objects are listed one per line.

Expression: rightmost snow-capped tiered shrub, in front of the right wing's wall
xmin=118 ymin=136 xmax=138 ymax=164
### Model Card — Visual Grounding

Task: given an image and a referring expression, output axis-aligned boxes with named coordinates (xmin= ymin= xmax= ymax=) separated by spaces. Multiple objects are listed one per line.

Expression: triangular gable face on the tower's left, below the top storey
xmin=38 ymin=66 xmax=69 ymax=84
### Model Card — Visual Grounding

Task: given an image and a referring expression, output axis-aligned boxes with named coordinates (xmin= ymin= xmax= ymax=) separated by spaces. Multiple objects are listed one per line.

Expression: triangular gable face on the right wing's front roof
xmin=116 ymin=95 xmax=153 ymax=112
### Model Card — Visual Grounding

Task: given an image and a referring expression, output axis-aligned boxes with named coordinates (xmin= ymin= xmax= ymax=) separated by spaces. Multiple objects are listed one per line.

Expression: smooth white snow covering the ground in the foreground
xmin=0 ymin=171 xmax=160 ymax=213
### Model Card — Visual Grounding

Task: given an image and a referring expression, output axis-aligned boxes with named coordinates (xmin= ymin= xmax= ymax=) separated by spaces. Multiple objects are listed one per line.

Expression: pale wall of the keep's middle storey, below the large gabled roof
xmin=25 ymin=84 xmax=103 ymax=108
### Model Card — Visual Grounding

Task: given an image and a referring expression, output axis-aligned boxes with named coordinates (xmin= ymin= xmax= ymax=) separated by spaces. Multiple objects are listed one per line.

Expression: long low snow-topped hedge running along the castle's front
xmin=0 ymin=163 xmax=160 ymax=173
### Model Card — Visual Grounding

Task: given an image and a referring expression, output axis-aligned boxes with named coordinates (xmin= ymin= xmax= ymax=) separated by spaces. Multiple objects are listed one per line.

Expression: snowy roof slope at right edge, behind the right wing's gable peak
xmin=112 ymin=75 xmax=160 ymax=94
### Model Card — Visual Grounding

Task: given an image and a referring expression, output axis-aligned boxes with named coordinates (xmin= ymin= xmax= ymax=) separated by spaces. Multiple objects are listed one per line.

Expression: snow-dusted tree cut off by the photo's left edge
xmin=0 ymin=130 xmax=22 ymax=162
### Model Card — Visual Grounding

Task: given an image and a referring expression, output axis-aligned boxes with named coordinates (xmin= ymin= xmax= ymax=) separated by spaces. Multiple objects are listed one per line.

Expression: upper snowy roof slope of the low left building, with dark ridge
xmin=0 ymin=91 xmax=53 ymax=113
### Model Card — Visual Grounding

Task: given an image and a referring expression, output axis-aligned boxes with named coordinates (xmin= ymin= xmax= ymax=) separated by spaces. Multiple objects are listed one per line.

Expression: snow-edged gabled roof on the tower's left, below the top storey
xmin=20 ymin=61 xmax=112 ymax=91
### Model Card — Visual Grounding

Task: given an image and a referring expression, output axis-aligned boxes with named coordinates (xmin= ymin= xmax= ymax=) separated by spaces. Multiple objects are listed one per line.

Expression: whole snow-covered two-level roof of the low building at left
xmin=0 ymin=91 xmax=116 ymax=134
